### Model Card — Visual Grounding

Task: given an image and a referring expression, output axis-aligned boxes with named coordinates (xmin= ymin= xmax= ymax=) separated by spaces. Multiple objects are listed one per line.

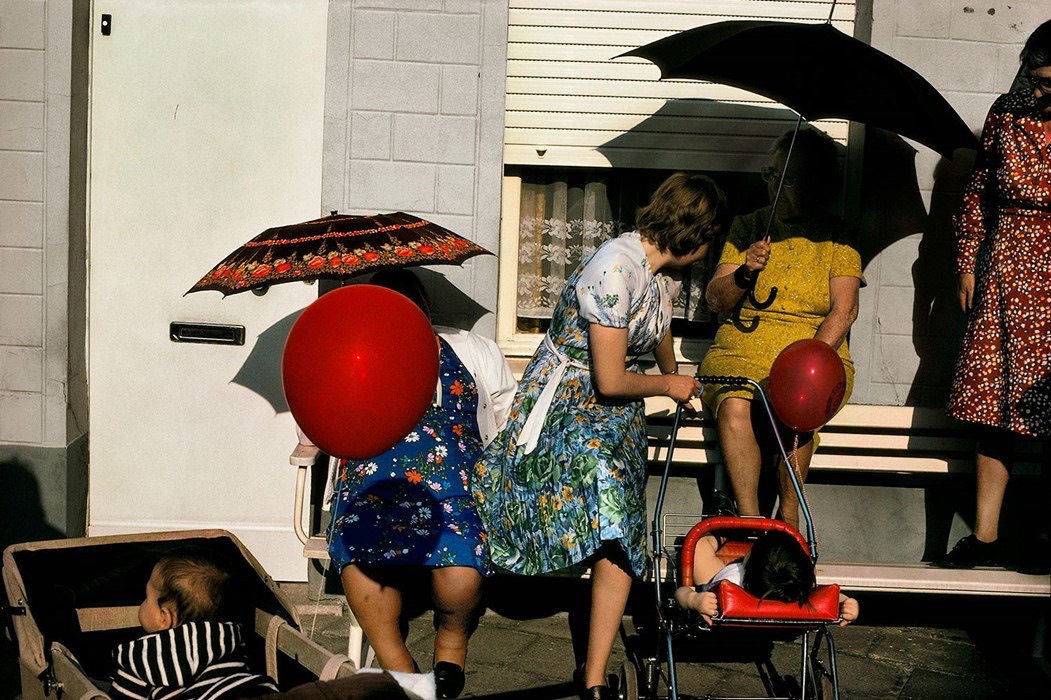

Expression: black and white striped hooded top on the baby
xmin=109 ymin=622 xmax=277 ymax=700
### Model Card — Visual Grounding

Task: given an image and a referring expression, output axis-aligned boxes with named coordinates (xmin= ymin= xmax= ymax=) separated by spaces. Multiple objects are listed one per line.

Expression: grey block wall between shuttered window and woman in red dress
xmin=851 ymin=0 xmax=1051 ymax=406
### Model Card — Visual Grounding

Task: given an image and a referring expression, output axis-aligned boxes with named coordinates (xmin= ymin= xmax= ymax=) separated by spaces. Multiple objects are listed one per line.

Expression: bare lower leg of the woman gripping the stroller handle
xmin=584 ymin=546 xmax=632 ymax=688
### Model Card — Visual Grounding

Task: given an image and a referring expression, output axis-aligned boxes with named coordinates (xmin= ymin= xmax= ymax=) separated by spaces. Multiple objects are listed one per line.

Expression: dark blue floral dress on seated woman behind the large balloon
xmin=329 ymin=338 xmax=492 ymax=576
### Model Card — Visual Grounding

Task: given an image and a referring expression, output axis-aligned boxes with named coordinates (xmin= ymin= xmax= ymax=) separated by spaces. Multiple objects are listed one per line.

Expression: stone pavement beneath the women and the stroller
xmin=282 ymin=576 xmax=1051 ymax=700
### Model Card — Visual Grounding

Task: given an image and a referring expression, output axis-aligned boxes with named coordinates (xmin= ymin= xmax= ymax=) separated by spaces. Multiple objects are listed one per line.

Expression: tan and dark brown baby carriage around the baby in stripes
xmin=2 ymin=530 xmax=357 ymax=700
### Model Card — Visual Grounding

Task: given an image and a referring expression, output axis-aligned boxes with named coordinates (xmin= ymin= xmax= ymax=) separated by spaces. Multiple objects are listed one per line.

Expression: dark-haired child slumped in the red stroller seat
xmin=675 ymin=530 xmax=859 ymax=626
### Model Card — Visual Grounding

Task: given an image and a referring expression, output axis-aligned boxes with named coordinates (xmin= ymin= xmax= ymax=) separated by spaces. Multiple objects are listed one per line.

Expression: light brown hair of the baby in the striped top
xmin=154 ymin=547 xmax=232 ymax=624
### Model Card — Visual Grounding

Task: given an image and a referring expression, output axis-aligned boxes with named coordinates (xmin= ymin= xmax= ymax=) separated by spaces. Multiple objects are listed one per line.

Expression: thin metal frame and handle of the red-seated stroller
xmin=618 ymin=376 xmax=839 ymax=700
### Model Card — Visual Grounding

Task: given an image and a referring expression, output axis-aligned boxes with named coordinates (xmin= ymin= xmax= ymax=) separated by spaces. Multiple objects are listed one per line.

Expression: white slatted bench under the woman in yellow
xmin=646 ymin=398 xmax=1051 ymax=597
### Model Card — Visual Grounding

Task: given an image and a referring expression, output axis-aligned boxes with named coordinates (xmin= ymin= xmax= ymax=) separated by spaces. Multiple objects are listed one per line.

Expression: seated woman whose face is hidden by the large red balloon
xmin=329 ymin=270 xmax=515 ymax=698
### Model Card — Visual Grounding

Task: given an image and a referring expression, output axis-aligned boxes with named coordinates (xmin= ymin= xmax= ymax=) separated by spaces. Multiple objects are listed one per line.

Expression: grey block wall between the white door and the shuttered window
xmin=323 ymin=0 xmax=507 ymax=335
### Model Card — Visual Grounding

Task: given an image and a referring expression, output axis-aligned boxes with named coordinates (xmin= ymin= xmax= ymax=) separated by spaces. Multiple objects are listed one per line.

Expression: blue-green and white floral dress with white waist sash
xmin=472 ymin=233 xmax=681 ymax=577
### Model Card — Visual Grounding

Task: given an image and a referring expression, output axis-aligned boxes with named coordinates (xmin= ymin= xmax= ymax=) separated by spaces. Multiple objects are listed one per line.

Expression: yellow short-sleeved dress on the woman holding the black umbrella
xmin=700 ymin=207 xmax=865 ymax=415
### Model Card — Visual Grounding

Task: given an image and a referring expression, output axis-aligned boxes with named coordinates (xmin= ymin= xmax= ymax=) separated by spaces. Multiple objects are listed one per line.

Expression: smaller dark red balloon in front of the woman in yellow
xmin=769 ymin=338 xmax=847 ymax=432
